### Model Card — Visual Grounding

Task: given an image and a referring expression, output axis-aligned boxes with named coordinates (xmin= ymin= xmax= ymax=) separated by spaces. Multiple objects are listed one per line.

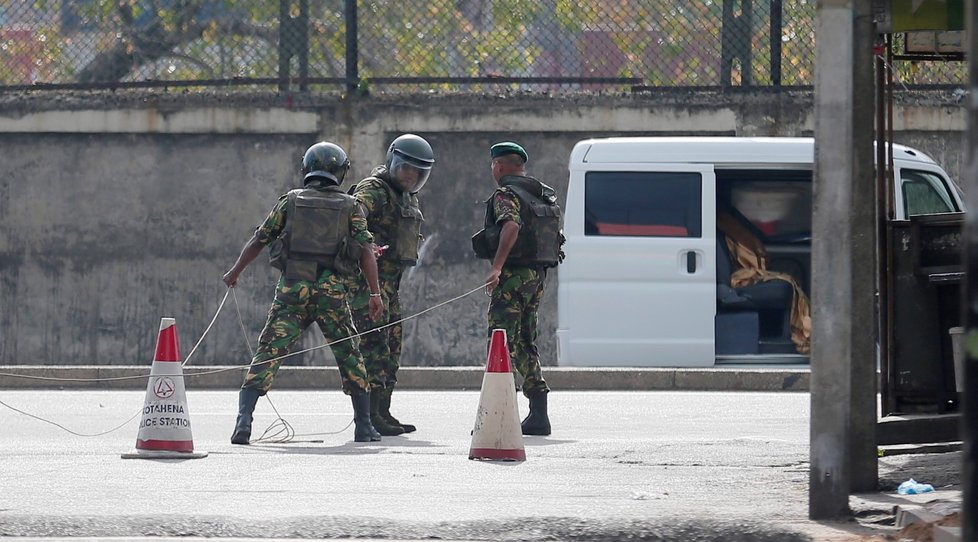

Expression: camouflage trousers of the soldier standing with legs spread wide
xmin=241 ymin=270 xmax=368 ymax=395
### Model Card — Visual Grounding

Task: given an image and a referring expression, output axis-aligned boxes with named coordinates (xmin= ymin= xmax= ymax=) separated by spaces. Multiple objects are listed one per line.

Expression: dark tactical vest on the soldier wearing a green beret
xmin=476 ymin=175 xmax=562 ymax=267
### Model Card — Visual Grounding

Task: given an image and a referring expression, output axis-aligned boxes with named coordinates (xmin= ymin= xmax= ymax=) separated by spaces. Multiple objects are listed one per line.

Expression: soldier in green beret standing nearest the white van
xmin=472 ymin=141 xmax=563 ymax=435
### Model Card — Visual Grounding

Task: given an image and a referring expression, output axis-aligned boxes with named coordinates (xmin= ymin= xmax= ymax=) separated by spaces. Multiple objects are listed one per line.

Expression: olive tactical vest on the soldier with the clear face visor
xmin=357 ymin=177 xmax=424 ymax=265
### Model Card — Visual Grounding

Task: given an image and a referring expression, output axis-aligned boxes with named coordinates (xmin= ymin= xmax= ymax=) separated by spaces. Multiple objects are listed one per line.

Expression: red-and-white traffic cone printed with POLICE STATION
xmin=122 ymin=318 xmax=207 ymax=459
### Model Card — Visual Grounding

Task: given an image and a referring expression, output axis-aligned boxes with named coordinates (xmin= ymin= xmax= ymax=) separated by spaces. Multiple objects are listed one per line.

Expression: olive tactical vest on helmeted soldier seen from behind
xmin=270 ymin=186 xmax=356 ymax=281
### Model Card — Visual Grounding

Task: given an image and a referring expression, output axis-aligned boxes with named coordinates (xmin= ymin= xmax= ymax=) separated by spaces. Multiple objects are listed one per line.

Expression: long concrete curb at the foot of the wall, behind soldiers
xmin=0 ymin=365 xmax=810 ymax=392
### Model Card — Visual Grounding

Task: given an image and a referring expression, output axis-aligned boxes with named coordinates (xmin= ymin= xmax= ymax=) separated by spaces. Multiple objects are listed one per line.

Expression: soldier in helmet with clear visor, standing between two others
xmin=350 ymin=134 xmax=435 ymax=435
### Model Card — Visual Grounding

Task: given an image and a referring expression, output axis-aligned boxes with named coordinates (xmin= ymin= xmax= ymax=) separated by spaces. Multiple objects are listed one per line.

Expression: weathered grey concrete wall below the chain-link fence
xmin=0 ymin=93 xmax=966 ymax=366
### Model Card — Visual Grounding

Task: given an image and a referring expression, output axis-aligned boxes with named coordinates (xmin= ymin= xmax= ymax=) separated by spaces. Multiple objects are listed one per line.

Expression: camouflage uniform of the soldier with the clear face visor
xmin=349 ymin=167 xmax=418 ymax=390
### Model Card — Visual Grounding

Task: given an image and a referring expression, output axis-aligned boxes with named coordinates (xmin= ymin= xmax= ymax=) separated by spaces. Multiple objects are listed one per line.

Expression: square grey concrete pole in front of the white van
xmin=808 ymin=0 xmax=878 ymax=519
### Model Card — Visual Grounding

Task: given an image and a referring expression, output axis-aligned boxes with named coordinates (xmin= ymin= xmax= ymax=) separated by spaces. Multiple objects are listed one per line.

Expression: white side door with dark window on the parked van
xmin=559 ymin=164 xmax=716 ymax=367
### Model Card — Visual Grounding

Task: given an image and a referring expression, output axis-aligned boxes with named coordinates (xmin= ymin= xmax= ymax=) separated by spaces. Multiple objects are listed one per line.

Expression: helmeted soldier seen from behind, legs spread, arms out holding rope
xmin=224 ymin=142 xmax=383 ymax=444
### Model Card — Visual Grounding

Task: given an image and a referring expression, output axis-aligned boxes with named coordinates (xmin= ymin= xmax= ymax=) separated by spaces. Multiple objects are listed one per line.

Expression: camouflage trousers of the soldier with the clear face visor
xmin=349 ymin=271 xmax=403 ymax=390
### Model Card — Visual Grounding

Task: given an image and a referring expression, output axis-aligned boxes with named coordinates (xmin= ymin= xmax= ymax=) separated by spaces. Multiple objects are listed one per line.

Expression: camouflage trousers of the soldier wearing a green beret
xmin=489 ymin=267 xmax=550 ymax=397
